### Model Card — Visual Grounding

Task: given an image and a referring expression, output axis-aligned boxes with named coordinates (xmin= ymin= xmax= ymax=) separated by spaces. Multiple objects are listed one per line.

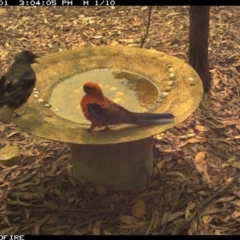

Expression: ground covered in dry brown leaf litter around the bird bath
xmin=0 ymin=6 xmax=240 ymax=235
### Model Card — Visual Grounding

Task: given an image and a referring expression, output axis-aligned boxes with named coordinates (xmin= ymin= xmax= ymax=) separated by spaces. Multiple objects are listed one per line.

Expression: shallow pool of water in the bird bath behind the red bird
xmin=50 ymin=69 xmax=160 ymax=123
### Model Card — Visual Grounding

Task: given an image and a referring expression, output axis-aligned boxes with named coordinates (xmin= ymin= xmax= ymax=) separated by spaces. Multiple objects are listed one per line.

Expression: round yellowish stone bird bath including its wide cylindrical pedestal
xmin=14 ymin=46 xmax=203 ymax=191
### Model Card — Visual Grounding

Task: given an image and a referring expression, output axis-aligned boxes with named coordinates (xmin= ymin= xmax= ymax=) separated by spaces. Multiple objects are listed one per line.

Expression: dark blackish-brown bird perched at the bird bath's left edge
xmin=0 ymin=51 xmax=39 ymax=123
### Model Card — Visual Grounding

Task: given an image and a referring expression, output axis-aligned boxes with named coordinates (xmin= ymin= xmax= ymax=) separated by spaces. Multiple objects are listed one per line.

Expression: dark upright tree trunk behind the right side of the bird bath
xmin=189 ymin=6 xmax=210 ymax=92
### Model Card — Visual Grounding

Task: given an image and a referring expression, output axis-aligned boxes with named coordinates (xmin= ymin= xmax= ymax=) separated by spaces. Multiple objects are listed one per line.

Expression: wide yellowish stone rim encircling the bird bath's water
xmin=13 ymin=46 xmax=203 ymax=145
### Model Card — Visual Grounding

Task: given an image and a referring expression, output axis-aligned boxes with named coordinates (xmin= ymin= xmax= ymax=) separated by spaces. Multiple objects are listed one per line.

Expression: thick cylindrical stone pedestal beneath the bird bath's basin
xmin=70 ymin=138 xmax=153 ymax=191
